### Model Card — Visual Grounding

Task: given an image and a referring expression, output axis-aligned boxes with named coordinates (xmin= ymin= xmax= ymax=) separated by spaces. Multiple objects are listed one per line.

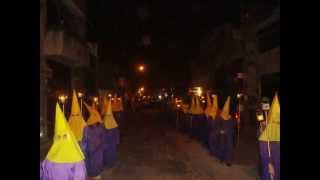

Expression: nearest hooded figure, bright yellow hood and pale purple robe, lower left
xmin=40 ymin=103 xmax=87 ymax=180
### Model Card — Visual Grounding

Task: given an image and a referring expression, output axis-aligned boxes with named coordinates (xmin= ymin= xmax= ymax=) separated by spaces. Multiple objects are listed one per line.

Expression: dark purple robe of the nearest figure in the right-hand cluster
xmin=216 ymin=118 xmax=236 ymax=162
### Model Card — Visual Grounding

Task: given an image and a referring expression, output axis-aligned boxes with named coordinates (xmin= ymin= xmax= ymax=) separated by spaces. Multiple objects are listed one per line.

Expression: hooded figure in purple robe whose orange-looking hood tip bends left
xmin=81 ymin=103 xmax=105 ymax=179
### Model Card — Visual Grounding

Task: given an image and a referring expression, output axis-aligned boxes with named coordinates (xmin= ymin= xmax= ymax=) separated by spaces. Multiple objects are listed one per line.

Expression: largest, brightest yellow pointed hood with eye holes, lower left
xmin=46 ymin=103 xmax=84 ymax=163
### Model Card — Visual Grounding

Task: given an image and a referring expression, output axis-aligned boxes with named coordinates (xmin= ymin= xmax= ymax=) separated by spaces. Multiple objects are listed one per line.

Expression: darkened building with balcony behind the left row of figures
xmin=40 ymin=0 xmax=97 ymax=139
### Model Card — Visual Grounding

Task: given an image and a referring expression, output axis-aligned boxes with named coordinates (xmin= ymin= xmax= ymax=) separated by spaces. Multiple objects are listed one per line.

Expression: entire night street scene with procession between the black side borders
xmin=40 ymin=0 xmax=281 ymax=180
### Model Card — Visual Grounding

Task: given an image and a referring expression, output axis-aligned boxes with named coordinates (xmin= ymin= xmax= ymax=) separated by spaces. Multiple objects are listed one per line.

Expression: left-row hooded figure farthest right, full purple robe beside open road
xmin=103 ymin=100 xmax=120 ymax=167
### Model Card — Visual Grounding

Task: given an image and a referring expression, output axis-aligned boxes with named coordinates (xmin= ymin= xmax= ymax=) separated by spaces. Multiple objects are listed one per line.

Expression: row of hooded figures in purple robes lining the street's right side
xmin=173 ymin=93 xmax=280 ymax=180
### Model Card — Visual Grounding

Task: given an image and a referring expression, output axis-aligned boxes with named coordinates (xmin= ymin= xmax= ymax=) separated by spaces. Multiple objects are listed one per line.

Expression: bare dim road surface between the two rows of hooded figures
xmin=102 ymin=107 xmax=257 ymax=180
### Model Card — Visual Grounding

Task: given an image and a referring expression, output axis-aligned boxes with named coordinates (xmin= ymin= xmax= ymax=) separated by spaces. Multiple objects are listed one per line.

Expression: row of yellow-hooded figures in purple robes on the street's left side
xmin=40 ymin=91 xmax=123 ymax=180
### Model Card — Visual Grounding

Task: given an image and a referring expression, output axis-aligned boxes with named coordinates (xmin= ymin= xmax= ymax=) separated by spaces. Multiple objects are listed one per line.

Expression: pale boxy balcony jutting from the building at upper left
xmin=43 ymin=30 xmax=89 ymax=67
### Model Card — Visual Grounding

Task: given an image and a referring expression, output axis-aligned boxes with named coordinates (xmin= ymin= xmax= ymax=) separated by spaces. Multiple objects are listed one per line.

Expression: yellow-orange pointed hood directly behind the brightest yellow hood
xmin=69 ymin=90 xmax=87 ymax=141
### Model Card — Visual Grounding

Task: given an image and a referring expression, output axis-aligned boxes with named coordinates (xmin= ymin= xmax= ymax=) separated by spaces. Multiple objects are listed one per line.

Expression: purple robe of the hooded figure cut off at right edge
xmin=259 ymin=141 xmax=280 ymax=180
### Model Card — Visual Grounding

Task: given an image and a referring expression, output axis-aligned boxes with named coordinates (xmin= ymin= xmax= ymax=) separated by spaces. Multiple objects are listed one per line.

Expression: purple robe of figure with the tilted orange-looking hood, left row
xmin=81 ymin=124 xmax=105 ymax=177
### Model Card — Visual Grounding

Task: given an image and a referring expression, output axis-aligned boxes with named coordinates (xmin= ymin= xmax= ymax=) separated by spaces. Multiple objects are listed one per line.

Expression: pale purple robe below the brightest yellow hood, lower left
xmin=40 ymin=159 xmax=87 ymax=180
